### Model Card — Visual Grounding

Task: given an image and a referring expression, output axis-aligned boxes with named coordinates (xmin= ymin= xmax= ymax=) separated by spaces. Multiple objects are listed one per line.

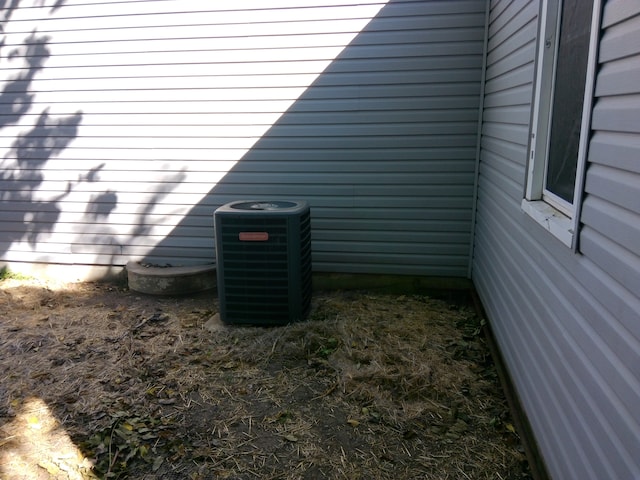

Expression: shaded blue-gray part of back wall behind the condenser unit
xmin=146 ymin=1 xmax=484 ymax=276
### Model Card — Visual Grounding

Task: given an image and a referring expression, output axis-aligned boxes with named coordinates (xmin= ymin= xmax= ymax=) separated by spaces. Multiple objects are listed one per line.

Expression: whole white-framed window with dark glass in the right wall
xmin=522 ymin=0 xmax=600 ymax=248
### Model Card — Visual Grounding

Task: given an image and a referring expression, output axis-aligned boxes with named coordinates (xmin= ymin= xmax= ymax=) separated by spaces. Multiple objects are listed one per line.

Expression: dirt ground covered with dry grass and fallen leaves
xmin=0 ymin=277 xmax=531 ymax=480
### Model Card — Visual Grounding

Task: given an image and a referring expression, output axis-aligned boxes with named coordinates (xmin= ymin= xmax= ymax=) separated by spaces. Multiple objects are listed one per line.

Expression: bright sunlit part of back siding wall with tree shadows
xmin=0 ymin=0 xmax=386 ymax=264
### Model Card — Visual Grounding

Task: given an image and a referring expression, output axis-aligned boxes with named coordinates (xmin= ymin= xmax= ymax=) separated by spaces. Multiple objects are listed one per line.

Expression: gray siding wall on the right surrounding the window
xmin=472 ymin=1 xmax=640 ymax=480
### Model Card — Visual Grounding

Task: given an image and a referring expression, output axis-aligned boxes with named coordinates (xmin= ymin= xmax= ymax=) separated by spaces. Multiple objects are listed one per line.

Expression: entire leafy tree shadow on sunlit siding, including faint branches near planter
xmin=0 ymin=0 xmax=198 ymax=265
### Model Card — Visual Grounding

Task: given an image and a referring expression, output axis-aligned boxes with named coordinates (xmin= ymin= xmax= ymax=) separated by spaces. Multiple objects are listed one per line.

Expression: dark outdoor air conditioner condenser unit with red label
xmin=214 ymin=201 xmax=311 ymax=325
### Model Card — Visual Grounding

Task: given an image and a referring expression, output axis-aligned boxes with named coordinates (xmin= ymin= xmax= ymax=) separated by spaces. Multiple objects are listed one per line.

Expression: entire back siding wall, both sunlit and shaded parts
xmin=0 ymin=0 xmax=485 ymax=276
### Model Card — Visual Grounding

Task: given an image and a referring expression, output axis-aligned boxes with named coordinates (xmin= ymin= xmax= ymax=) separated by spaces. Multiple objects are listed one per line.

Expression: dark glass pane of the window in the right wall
xmin=545 ymin=0 xmax=593 ymax=203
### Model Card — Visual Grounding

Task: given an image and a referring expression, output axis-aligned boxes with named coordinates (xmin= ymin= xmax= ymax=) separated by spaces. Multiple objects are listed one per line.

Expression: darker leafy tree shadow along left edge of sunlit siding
xmin=0 ymin=0 xmax=85 ymax=255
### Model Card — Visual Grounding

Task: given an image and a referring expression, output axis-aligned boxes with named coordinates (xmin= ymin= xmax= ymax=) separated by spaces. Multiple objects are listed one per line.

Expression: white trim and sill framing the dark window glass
xmin=521 ymin=0 xmax=602 ymax=251
